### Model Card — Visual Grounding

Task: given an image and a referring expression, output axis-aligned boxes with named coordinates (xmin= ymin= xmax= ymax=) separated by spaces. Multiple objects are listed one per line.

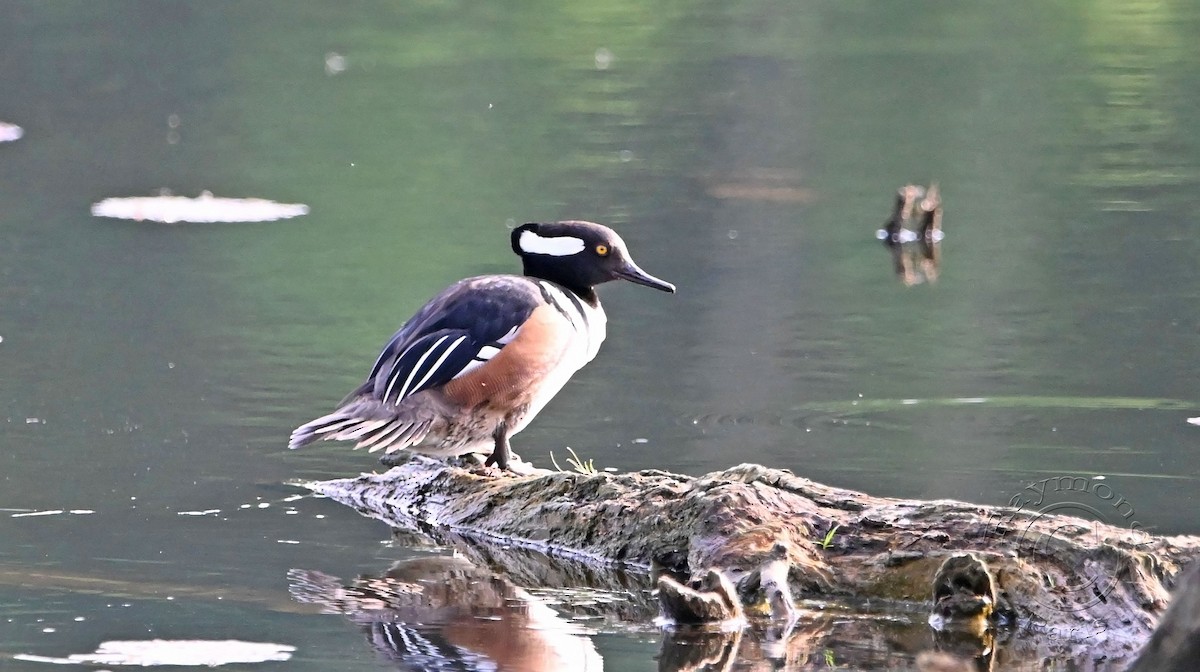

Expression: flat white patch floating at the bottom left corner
xmin=12 ymin=640 xmax=296 ymax=667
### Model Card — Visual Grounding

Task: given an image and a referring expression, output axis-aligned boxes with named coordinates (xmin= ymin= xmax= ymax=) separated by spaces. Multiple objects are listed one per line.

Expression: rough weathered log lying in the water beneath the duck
xmin=305 ymin=456 xmax=1200 ymax=658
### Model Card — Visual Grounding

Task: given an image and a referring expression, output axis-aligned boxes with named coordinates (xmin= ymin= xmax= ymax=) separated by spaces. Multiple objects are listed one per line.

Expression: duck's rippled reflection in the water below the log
xmin=288 ymin=556 xmax=604 ymax=672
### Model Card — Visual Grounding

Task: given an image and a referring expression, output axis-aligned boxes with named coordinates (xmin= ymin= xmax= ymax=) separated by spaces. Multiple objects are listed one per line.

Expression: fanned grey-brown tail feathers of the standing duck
xmin=288 ymin=402 xmax=431 ymax=452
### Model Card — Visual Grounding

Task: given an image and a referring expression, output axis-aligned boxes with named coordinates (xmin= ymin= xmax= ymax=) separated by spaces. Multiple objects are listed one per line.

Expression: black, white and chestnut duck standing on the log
xmin=288 ymin=220 xmax=676 ymax=472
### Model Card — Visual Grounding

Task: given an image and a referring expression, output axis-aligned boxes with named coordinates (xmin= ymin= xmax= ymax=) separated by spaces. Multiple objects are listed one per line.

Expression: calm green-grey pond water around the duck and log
xmin=0 ymin=0 xmax=1200 ymax=670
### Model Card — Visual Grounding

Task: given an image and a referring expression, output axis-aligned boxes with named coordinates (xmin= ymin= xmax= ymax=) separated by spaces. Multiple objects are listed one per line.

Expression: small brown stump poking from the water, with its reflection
xmin=875 ymin=182 xmax=944 ymax=287
